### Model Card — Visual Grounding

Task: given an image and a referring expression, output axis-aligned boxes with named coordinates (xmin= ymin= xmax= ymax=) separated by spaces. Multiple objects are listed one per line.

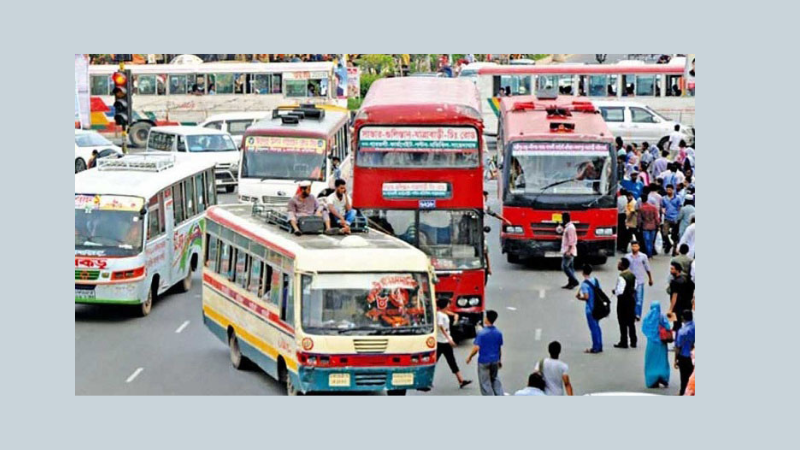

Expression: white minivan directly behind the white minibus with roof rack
xmin=146 ymin=126 xmax=240 ymax=192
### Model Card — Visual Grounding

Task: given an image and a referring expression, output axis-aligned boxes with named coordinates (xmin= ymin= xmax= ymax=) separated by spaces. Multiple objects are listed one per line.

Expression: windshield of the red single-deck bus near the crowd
xmin=507 ymin=142 xmax=612 ymax=195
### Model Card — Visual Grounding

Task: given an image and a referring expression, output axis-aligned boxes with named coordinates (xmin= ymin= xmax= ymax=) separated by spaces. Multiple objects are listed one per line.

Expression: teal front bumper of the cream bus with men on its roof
xmin=298 ymin=363 xmax=436 ymax=392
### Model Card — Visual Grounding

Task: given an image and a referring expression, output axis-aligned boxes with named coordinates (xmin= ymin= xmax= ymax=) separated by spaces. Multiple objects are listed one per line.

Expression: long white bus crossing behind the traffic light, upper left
xmin=89 ymin=62 xmax=347 ymax=147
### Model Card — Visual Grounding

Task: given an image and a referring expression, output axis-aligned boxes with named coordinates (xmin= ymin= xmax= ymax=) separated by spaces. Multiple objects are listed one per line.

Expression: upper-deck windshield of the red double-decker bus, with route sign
xmin=356 ymin=126 xmax=480 ymax=168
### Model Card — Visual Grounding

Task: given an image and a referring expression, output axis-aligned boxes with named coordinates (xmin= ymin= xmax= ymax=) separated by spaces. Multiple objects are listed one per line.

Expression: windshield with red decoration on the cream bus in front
xmin=301 ymin=273 xmax=435 ymax=335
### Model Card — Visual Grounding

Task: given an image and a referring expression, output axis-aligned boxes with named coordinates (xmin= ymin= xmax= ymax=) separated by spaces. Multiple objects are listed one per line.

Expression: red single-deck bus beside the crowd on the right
xmin=497 ymin=96 xmax=617 ymax=264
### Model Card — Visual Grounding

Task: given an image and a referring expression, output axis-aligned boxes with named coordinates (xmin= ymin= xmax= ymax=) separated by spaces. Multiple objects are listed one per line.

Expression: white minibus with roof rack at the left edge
xmin=75 ymin=154 xmax=216 ymax=316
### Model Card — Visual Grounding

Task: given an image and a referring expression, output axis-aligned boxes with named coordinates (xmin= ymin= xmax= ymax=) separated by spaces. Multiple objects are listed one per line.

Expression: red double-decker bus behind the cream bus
xmin=353 ymin=77 xmax=485 ymax=336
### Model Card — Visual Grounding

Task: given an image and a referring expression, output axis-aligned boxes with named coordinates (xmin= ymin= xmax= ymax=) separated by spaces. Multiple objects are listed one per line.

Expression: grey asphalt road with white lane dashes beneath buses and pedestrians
xmin=75 ymin=182 xmax=679 ymax=395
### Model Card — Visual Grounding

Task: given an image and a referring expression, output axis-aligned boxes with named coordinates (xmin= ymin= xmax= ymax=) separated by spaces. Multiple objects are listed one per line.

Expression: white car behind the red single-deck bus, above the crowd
xmin=592 ymin=100 xmax=694 ymax=148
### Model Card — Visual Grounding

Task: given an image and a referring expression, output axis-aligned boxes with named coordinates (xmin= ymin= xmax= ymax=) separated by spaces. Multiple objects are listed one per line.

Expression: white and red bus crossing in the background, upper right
xmin=460 ymin=57 xmax=695 ymax=135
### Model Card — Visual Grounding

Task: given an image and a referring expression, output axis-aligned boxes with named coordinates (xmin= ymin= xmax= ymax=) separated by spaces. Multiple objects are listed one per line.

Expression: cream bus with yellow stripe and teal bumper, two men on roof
xmin=203 ymin=204 xmax=436 ymax=395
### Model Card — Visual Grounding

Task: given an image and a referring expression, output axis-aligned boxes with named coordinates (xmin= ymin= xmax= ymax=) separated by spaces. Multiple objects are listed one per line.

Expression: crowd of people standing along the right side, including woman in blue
xmin=561 ymin=129 xmax=696 ymax=395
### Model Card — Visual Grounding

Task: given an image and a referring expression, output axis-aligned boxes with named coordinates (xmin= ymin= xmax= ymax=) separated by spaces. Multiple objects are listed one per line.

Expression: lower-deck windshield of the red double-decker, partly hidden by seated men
xmin=364 ymin=210 xmax=483 ymax=270
